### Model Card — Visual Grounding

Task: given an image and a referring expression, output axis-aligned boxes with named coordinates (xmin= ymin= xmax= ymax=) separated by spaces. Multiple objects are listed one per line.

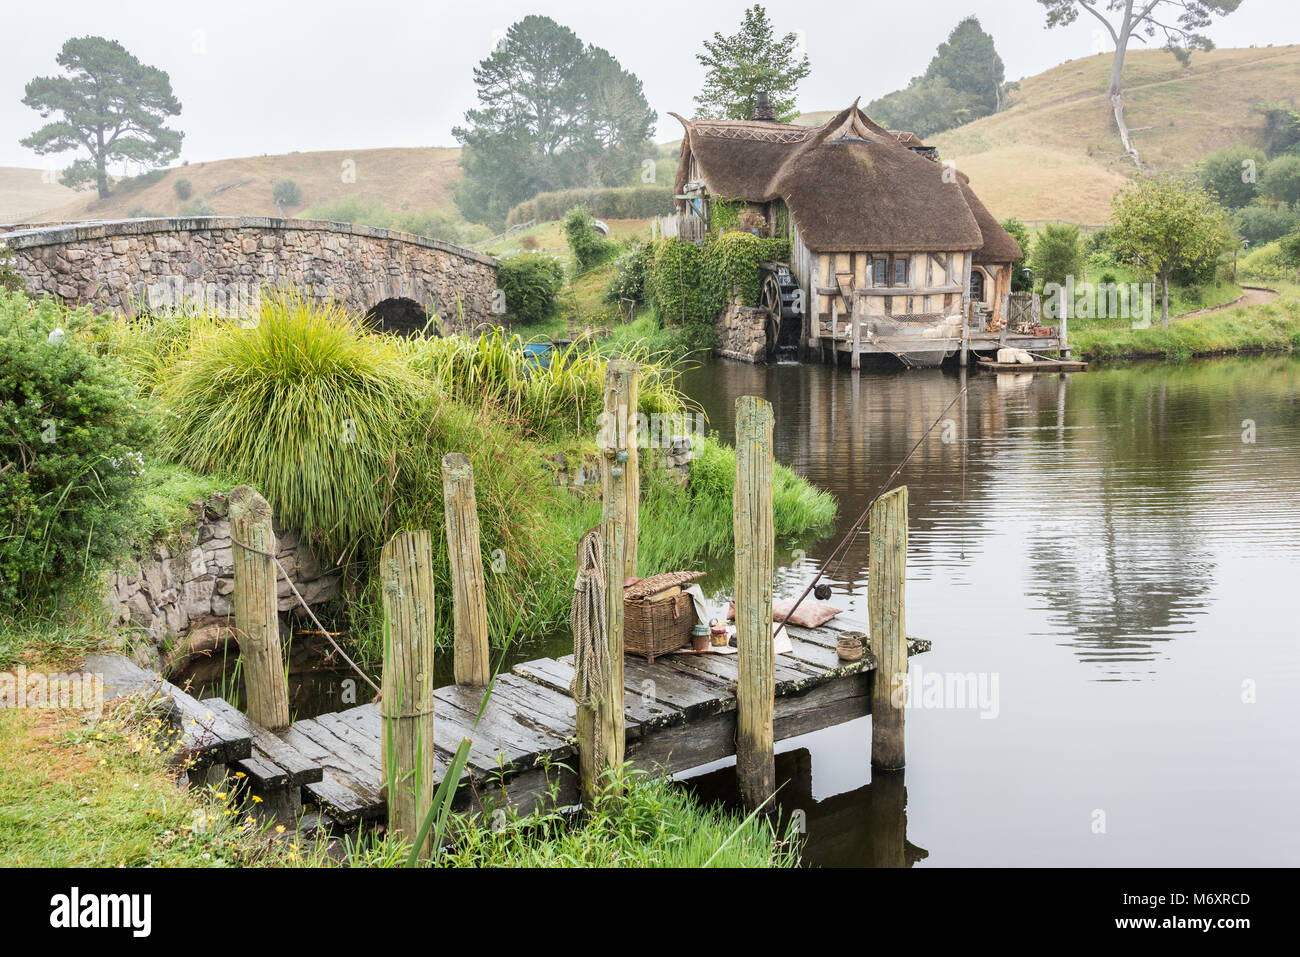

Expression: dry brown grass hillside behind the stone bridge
xmin=24 ymin=147 xmax=460 ymax=220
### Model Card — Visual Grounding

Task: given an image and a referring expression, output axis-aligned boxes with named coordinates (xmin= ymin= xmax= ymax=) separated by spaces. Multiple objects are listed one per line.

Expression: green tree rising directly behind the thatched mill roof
xmin=696 ymin=4 xmax=813 ymax=121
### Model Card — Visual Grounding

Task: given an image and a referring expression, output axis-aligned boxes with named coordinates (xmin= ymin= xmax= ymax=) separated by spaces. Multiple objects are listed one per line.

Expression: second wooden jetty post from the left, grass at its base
xmin=380 ymin=532 xmax=434 ymax=856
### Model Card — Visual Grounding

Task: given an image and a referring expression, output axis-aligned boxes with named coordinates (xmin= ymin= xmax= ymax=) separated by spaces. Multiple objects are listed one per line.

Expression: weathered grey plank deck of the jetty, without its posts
xmin=164 ymin=623 xmax=930 ymax=824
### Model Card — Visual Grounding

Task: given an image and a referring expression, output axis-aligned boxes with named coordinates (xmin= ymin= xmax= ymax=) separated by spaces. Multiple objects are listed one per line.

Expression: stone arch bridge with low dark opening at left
xmin=0 ymin=216 xmax=502 ymax=332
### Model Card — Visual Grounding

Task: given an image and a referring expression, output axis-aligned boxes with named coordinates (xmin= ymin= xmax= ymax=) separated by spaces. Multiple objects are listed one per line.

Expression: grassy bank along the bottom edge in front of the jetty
xmin=0 ymin=681 xmax=798 ymax=867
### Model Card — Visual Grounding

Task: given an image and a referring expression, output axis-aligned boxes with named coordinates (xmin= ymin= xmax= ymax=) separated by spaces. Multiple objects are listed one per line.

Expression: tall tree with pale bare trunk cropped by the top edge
xmin=1039 ymin=0 xmax=1242 ymax=169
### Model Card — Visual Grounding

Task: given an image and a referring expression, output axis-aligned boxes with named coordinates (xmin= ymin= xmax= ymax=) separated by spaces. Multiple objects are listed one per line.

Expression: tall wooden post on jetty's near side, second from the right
xmin=733 ymin=395 xmax=776 ymax=809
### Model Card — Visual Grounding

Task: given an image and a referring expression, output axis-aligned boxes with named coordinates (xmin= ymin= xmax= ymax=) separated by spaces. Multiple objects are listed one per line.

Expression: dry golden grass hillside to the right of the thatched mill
xmin=931 ymin=46 xmax=1300 ymax=222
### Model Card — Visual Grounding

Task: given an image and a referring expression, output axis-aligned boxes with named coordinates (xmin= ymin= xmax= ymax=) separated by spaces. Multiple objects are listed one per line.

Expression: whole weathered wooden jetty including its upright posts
xmin=147 ymin=361 xmax=930 ymax=853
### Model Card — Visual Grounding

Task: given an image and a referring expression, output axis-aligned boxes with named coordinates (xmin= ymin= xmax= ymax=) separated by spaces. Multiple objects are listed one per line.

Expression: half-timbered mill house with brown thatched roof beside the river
xmin=666 ymin=96 xmax=1060 ymax=365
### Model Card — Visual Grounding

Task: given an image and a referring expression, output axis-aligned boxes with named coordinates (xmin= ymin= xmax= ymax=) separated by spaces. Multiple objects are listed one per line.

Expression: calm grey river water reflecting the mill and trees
xmin=684 ymin=359 xmax=1300 ymax=866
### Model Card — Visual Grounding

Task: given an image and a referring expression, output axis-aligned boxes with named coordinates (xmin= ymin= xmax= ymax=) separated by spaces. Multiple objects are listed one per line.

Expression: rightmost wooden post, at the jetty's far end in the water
xmin=867 ymin=485 xmax=907 ymax=771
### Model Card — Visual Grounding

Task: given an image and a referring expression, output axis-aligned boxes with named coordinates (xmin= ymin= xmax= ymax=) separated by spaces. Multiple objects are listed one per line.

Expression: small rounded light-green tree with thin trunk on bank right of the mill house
xmin=1110 ymin=173 xmax=1236 ymax=329
